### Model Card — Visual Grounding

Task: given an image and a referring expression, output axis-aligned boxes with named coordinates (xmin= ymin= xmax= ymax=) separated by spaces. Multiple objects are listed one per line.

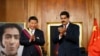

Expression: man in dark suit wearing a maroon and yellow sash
xmin=20 ymin=16 xmax=45 ymax=56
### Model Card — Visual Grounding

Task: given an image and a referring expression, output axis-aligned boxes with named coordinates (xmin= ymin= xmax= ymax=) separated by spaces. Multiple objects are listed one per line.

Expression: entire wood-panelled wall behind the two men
xmin=0 ymin=0 xmax=100 ymax=54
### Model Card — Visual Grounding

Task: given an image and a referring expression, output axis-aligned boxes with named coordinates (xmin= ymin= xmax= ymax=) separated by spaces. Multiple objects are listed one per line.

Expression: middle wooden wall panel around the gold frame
xmin=41 ymin=0 xmax=88 ymax=53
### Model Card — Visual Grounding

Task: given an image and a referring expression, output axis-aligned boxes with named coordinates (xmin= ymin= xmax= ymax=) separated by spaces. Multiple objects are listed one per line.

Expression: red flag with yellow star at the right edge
xmin=88 ymin=19 xmax=100 ymax=56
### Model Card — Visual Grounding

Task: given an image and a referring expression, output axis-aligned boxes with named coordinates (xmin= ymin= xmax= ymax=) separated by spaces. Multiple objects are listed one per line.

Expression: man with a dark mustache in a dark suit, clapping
xmin=53 ymin=11 xmax=80 ymax=56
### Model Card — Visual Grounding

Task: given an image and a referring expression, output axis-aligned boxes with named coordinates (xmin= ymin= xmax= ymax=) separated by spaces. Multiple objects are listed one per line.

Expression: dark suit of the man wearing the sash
xmin=20 ymin=29 xmax=45 ymax=56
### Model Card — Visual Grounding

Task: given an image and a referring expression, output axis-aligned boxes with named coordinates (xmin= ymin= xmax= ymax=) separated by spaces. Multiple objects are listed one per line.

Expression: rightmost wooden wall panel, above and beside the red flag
xmin=86 ymin=0 xmax=100 ymax=43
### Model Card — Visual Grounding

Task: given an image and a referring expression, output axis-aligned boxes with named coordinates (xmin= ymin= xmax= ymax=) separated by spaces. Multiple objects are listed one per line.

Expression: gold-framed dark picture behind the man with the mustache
xmin=47 ymin=22 xmax=82 ymax=56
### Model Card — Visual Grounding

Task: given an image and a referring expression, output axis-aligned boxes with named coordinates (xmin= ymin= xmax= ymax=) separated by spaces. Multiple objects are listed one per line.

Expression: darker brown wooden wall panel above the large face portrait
xmin=6 ymin=0 xmax=27 ymax=22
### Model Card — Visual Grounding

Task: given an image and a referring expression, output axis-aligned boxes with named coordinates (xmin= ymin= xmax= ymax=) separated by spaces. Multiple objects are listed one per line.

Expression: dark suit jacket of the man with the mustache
xmin=53 ymin=23 xmax=80 ymax=56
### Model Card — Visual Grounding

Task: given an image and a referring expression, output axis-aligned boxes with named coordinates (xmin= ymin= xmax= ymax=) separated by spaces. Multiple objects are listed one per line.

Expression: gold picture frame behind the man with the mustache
xmin=47 ymin=22 xmax=83 ymax=56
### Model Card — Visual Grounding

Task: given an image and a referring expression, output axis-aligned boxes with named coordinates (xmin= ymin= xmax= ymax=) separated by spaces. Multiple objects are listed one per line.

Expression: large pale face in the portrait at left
xmin=2 ymin=28 xmax=20 ymax=55
